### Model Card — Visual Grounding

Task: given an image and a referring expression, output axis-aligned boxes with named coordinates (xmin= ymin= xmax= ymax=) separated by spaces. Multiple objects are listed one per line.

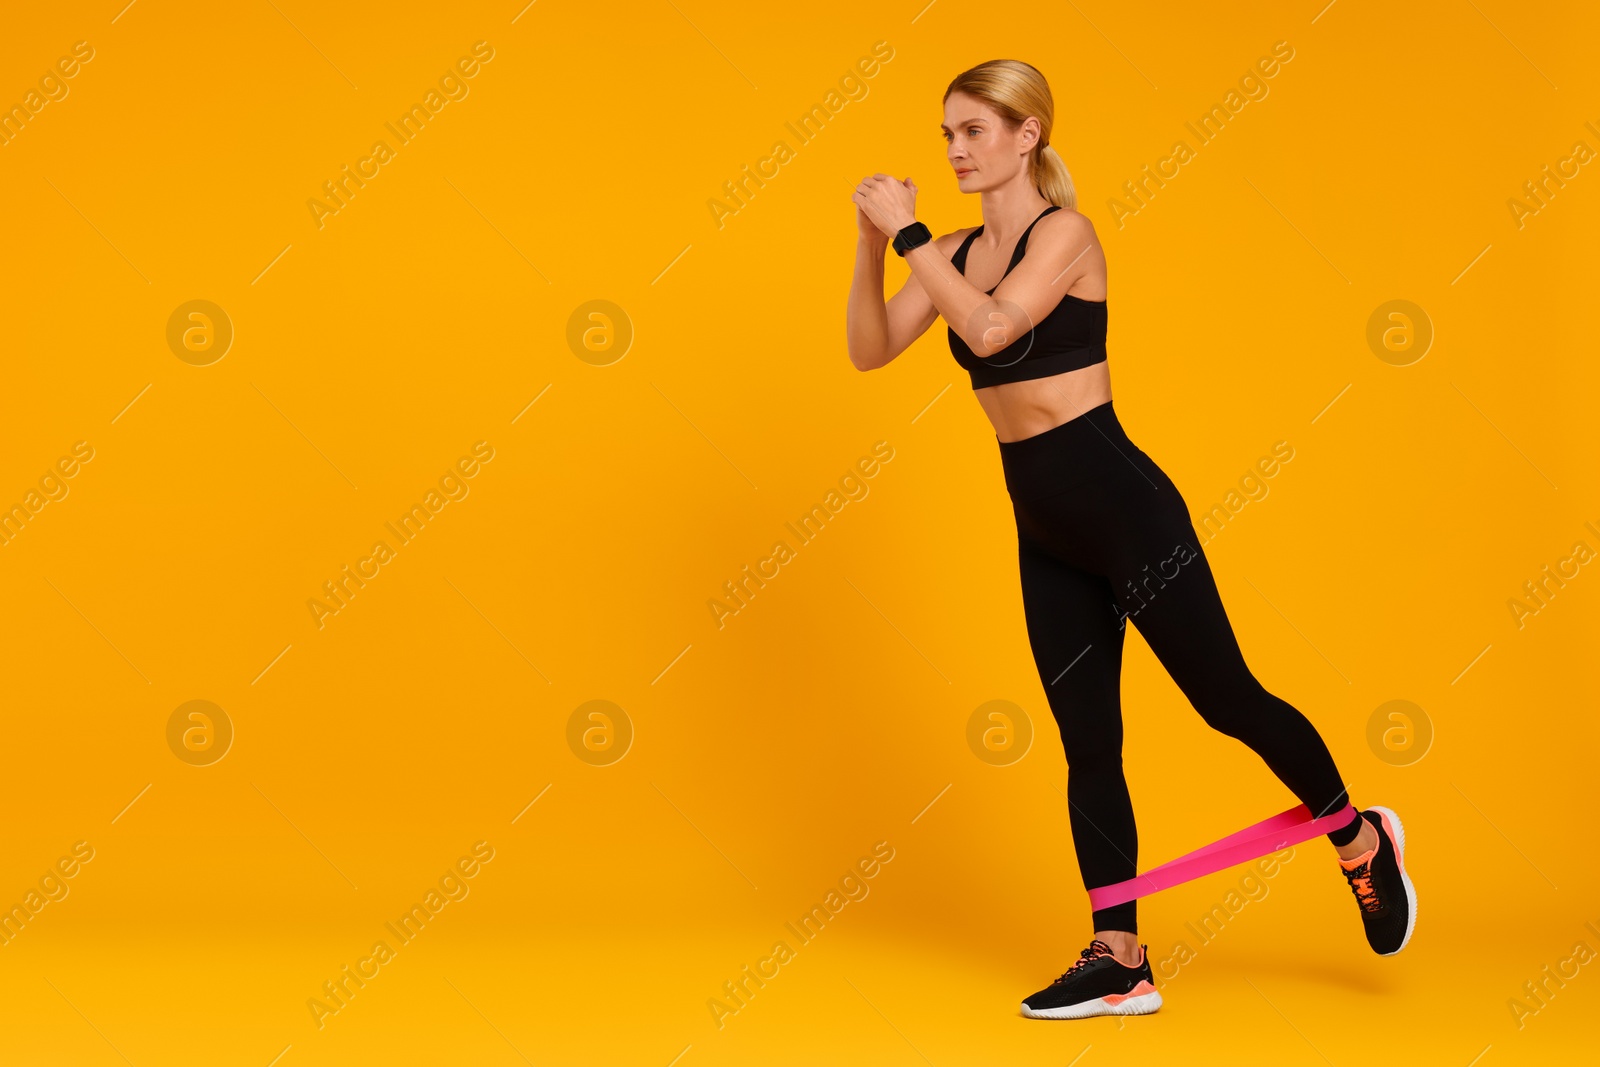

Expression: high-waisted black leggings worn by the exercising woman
xmin=997 ymin=402 xmax=1362 ymax=933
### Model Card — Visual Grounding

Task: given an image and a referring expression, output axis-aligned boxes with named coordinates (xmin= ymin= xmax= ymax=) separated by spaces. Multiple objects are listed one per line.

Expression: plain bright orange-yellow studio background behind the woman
xmin=0 ymin=0 xmax=1600 ymax=1067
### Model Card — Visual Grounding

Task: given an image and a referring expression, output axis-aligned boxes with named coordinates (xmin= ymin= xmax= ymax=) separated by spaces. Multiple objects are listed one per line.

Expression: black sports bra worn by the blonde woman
xmin=946 ymin=205 xmax=1106 ymax=389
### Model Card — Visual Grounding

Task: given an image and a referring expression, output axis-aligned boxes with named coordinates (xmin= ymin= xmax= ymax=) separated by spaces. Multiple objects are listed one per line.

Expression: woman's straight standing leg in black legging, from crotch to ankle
xmin=1018 ymin=536 xmax=1139 ymax=934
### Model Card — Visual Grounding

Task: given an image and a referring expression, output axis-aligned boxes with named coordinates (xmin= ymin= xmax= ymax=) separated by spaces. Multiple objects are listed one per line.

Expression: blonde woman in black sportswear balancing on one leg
xmin=848 ymin=59 xmax=1416 ymax=1019
